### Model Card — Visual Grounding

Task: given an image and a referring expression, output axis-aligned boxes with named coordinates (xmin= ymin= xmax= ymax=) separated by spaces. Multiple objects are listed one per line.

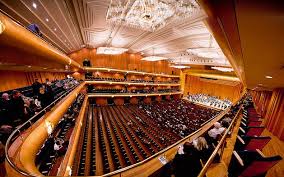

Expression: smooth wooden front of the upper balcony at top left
xmin=0 ymin=12 xmax=81 ymax=68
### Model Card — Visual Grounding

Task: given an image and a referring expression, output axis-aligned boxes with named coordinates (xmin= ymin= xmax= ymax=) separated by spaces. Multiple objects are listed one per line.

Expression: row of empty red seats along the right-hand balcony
xmin=229 ymin=98 xmax=282 ymax=177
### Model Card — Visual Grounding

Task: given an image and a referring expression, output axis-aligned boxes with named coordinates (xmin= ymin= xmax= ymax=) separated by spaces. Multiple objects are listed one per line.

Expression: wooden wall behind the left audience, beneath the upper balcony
xmin=0 ymin=71 xmax=66 ymax=92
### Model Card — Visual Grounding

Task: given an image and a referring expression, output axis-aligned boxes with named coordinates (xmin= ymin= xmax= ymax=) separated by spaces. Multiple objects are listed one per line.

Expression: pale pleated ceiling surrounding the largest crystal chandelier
xmin=0 ymin=0 xmax=230 ymax=66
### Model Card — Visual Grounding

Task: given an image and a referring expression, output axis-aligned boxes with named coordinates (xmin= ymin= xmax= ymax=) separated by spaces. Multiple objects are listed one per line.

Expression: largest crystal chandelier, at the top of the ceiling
xmin=106 ymin=0 xmax=200 ymax=32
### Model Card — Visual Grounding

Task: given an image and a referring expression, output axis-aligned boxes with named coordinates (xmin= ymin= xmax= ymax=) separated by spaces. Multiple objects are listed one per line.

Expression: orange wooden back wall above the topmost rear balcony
xmin=69 ymin=48 xmax=179 ymax=74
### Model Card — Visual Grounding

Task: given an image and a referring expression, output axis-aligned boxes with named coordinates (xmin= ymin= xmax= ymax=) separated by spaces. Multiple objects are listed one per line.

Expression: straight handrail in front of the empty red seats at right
xmin=198 ymin=107 xmax=242 ymax=177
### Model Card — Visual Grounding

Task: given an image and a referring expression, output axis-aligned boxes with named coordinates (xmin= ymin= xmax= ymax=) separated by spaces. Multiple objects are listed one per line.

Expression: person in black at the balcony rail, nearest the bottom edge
xmin=173 ymin=142 xmax=202 ymax=177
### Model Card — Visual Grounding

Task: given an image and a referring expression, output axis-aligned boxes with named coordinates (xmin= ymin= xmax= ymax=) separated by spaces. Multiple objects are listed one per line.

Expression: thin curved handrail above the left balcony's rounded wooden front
xmin=5 ymin=85 xmax=81 ymax=176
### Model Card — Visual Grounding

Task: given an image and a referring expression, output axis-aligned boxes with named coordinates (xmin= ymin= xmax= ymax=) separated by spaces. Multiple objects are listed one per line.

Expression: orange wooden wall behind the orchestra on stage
xmin=184 ymin=75 xmax=242 ymax=102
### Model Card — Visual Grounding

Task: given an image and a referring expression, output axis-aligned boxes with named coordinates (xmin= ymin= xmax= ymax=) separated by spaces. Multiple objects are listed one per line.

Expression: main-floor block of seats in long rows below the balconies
xmin=73 ymin=100 xmax=219 ymax=176
